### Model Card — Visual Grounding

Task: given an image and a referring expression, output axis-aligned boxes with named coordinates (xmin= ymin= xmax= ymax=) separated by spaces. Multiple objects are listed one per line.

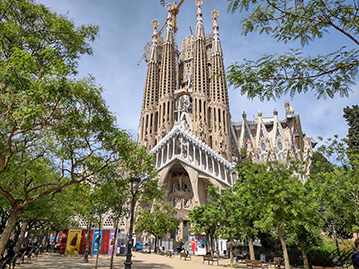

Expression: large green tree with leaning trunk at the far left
xmin=0 ymin=0 xmax=129 ymax=254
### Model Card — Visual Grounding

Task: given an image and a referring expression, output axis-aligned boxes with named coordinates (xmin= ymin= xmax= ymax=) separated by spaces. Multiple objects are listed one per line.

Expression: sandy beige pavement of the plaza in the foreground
xmin=16 ymin=253 xmax=240 ymax=269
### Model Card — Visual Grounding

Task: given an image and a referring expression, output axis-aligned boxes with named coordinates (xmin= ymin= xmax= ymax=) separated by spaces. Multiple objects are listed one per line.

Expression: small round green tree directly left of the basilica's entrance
xmin=136 ymin=202 xmax=178 ymax=251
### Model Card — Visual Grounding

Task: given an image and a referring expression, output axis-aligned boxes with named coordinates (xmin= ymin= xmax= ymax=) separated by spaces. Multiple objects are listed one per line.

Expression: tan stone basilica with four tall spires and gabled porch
xmin=138 ymin=0 xmax=312 ymax=238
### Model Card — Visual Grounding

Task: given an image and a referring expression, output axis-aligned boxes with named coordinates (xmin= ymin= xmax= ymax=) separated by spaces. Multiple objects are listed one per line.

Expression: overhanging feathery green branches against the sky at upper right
xmin=227 ymin=0 xmax=359 ymax=100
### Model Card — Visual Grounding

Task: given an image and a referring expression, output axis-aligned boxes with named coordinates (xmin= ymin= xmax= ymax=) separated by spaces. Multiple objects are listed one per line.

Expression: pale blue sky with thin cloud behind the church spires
xmin=37 ymin=0 xmax=359 ymax=144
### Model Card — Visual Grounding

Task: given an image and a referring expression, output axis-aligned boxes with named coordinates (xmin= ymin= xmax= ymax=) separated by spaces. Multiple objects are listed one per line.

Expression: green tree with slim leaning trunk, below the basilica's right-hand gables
xmin=242 ymin=159 xmax=307 ymax=269
